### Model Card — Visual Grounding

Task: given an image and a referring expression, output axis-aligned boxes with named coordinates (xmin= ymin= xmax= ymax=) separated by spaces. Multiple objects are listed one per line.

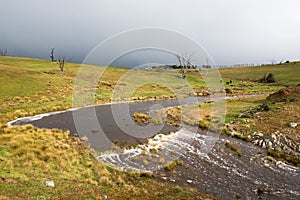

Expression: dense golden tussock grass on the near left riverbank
xmin=0 ymin=125 xmax=109 ymax=179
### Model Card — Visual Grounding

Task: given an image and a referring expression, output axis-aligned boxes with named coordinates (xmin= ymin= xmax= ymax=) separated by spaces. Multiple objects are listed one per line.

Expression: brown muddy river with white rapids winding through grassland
xmin=9 ymin=97 xmax=300 ymax=200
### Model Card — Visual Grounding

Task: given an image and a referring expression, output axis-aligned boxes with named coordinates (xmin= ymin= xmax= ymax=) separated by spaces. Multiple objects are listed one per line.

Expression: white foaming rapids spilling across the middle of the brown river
xmin=98 ymin=129 xmax=212 ymax=172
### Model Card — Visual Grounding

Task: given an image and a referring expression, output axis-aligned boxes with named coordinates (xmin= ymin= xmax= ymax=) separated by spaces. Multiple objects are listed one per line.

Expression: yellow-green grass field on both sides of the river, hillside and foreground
xmin=0 ymin=56 xmax=300 ymax=199
